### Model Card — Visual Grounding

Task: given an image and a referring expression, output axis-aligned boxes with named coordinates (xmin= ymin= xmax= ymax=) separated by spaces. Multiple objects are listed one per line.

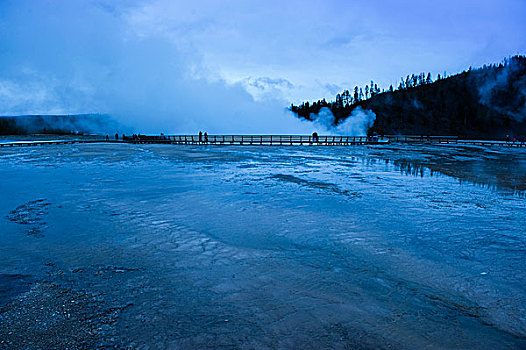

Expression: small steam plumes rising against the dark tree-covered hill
xmin=311 ymin=107 xmax=376 ymax=136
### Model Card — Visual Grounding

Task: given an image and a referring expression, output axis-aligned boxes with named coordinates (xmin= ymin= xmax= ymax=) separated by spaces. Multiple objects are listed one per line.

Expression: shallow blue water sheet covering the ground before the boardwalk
xmin=0 ymin=144 xmax=526 ymax=349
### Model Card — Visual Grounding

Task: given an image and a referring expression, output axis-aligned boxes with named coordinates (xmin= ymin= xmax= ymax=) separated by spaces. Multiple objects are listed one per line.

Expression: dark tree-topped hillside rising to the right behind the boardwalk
xmin=290 ymin=56 xmax=526 ymax=139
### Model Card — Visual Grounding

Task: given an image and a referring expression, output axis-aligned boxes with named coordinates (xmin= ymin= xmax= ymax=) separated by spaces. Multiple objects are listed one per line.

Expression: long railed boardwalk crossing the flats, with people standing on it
xmin=0 ymin=135 xmax=526 ymax=147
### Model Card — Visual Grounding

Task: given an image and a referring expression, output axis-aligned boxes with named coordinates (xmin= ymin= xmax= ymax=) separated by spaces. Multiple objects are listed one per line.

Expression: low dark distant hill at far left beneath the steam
xmin=0 ymin=114 xmax=118 ymax=135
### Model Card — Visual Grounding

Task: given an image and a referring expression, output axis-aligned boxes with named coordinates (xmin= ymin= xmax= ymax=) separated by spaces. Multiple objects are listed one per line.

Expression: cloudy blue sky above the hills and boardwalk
xmin=0 ymin=0 xmax=526 ymax=133
